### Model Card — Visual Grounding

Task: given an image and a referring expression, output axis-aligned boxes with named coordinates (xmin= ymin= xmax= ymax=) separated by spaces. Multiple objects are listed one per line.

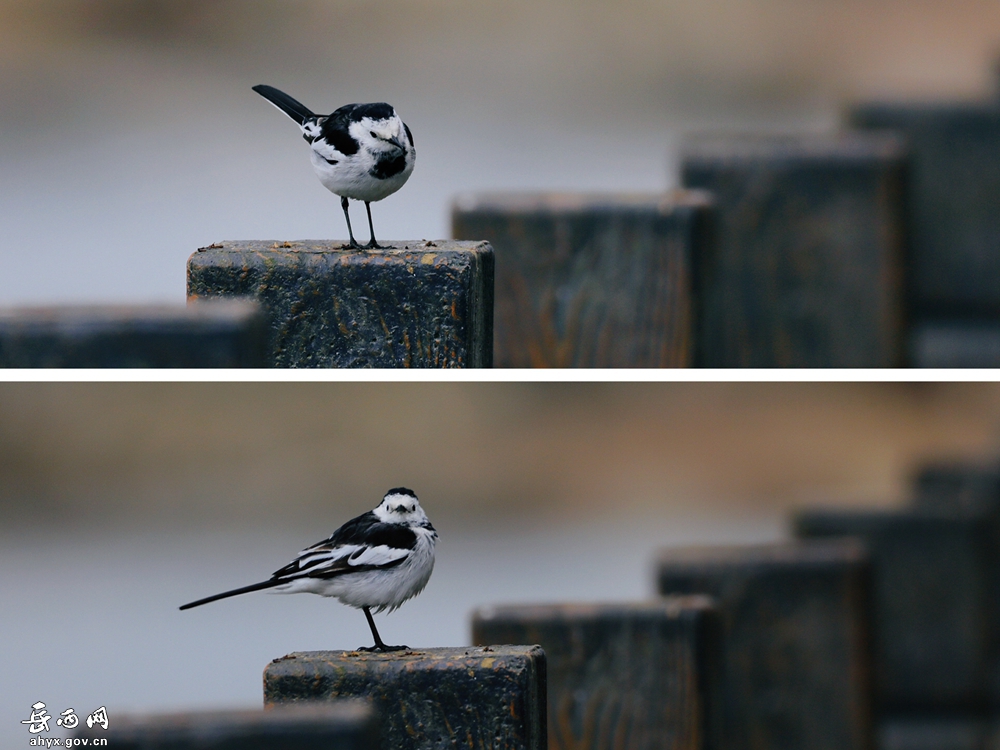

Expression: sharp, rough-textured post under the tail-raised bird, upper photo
xmin=188 ymin=240 xmax=493 ymax=367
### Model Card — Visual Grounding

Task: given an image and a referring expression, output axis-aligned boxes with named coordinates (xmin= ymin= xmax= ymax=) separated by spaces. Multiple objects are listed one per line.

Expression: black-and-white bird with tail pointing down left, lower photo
xmin=181 ymin=487 xmax=437 ymax=651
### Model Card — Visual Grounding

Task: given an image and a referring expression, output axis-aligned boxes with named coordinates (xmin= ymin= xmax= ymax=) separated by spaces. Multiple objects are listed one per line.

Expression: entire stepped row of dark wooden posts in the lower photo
xmin=84 ymin=465 xmax=1000 ymax=750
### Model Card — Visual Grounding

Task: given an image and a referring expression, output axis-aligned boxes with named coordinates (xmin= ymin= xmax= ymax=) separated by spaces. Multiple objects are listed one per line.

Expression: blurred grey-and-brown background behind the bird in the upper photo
xmin=0 ymin=0 xmax=1000 ymax=304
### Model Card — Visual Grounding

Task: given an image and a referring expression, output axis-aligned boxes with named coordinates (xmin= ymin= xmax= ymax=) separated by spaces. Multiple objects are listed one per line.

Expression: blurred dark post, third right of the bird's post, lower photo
xmin=795 ymin=507 xmax=1000 ymax=716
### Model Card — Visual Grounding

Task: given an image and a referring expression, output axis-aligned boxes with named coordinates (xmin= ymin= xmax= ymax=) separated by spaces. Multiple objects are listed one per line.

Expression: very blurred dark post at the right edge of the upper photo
xmin=848 ymin=100 xmax=1000 ymax=367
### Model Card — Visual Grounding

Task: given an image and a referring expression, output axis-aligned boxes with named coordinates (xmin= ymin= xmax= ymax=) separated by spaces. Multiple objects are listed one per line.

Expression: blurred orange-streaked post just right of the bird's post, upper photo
xmin=452 ymin=191 xmax=711 ymax=367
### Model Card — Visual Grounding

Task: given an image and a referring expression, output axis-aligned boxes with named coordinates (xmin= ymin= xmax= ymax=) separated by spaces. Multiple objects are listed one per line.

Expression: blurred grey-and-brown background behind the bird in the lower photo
xmin=0 ymin=383 xmax=1000 ymax=747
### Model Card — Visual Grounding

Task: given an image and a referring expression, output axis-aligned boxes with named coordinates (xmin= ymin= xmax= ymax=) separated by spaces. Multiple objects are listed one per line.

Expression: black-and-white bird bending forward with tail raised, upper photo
xmin=253 ymin=85 xmax=417 ymax=248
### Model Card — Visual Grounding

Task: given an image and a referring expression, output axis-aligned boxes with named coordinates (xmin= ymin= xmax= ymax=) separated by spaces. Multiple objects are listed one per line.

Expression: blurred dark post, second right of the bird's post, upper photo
xmin=682 ymin=133 xmax=905 ymax=367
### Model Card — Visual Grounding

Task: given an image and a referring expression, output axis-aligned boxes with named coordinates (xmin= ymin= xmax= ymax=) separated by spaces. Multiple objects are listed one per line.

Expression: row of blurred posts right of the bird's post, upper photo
xmin=452 ymin=89 xmax=1000 ymax=367
